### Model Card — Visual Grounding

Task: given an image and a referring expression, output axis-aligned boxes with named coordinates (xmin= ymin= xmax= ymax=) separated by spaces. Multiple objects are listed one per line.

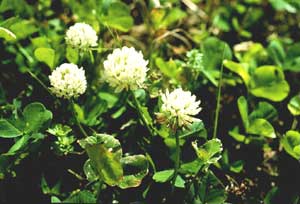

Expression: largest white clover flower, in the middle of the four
xmin=103 ymin=47 xmax=148 ymax=92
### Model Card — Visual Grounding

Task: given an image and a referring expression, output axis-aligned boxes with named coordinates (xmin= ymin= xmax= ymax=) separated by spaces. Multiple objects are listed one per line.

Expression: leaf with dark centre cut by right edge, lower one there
xmin=280 ymin=130 xmax=300 ymax=160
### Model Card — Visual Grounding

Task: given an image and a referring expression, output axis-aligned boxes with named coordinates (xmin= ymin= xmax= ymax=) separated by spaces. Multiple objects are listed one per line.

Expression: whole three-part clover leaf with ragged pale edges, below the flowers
xmin=79 ymin=134 xmax=148 ymax=189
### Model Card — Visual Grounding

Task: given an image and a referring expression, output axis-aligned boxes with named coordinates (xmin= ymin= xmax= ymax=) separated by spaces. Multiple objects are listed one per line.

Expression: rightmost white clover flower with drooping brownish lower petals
xmin=156 ymin=88 xmax=201 ymax=129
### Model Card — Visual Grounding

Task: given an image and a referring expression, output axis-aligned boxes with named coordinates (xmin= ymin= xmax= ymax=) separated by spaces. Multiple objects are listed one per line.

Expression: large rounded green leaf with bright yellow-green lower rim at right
xmin=249 ymin=66 xmax=290 ymax=102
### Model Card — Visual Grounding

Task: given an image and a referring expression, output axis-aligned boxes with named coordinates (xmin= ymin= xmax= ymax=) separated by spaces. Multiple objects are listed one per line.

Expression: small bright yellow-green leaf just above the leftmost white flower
xmin=34 ymin=47 xmax=55 ymax=69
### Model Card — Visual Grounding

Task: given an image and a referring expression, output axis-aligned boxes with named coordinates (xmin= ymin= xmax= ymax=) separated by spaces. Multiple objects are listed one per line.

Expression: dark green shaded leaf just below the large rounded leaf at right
xmin=249 ymin=101 xmax=278 ymax=121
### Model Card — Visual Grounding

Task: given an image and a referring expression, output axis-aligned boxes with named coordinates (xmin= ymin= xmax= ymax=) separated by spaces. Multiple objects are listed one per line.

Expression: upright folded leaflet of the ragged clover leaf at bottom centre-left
xmin=79 ymin=134 xmax=123 ymax=186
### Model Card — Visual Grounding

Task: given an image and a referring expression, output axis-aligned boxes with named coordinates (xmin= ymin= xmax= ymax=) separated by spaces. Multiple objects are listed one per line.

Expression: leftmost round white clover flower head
xmin=49 ymin=63 xmax=87 ymax=99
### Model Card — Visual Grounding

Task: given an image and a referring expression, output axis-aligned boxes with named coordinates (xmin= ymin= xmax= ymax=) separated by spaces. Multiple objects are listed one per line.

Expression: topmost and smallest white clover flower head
xmin=65 ymin=23 xmax=98 ymax=50
